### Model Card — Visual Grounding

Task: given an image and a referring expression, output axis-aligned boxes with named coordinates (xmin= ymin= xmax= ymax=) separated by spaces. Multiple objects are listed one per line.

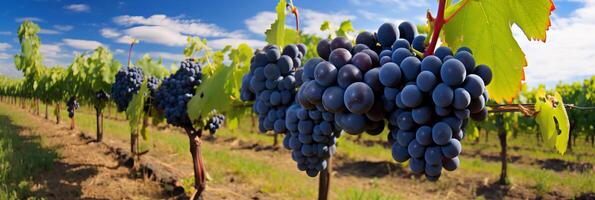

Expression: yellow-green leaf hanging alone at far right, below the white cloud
xmin=535 ymin=87 xmax=570 ymax=155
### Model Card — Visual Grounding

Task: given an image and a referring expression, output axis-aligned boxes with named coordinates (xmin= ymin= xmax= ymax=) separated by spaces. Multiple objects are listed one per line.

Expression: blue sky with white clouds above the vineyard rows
xmin=0 ymin=0 xmax=595 ymax=85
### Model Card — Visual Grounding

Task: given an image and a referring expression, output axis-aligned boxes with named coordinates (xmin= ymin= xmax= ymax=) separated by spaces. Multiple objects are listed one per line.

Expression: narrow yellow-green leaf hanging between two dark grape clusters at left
xmin=126 ymin=83 xmax=149 ymax=140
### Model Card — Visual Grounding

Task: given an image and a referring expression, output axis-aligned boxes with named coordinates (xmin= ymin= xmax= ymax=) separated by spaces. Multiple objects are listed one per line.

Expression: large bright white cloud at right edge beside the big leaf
xmin=513 ymin=0 xmax=595 ymax=86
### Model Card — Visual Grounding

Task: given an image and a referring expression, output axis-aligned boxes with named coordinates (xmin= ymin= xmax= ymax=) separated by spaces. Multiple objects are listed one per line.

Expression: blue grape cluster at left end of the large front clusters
xmin=240 ymin=44 xmax=306 ymax=133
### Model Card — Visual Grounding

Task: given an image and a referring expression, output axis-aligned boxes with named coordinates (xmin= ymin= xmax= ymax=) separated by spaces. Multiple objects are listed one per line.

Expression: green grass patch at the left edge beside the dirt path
xmin=0 ymin=104 xmax=58 ymax=199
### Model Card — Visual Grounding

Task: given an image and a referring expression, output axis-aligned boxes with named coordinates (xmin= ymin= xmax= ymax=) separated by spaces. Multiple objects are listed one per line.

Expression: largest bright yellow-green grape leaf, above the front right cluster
xmin=443 ymin=0 xmax=555 ymax=102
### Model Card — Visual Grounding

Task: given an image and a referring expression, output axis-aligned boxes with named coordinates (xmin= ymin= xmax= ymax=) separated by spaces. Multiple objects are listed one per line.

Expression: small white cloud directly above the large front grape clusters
xmin=300 ymin=9 xmax=355 ymax=36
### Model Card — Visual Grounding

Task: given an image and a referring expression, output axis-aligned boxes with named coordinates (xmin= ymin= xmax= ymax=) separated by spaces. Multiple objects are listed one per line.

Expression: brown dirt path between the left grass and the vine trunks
xmin=20 ymin=117 xmax=167 ymax=199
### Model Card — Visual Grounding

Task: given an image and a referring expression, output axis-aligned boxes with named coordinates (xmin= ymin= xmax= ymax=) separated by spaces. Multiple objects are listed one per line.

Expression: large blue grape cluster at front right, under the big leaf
xmin=358 ymin=22 xmax=492 ymax=181
